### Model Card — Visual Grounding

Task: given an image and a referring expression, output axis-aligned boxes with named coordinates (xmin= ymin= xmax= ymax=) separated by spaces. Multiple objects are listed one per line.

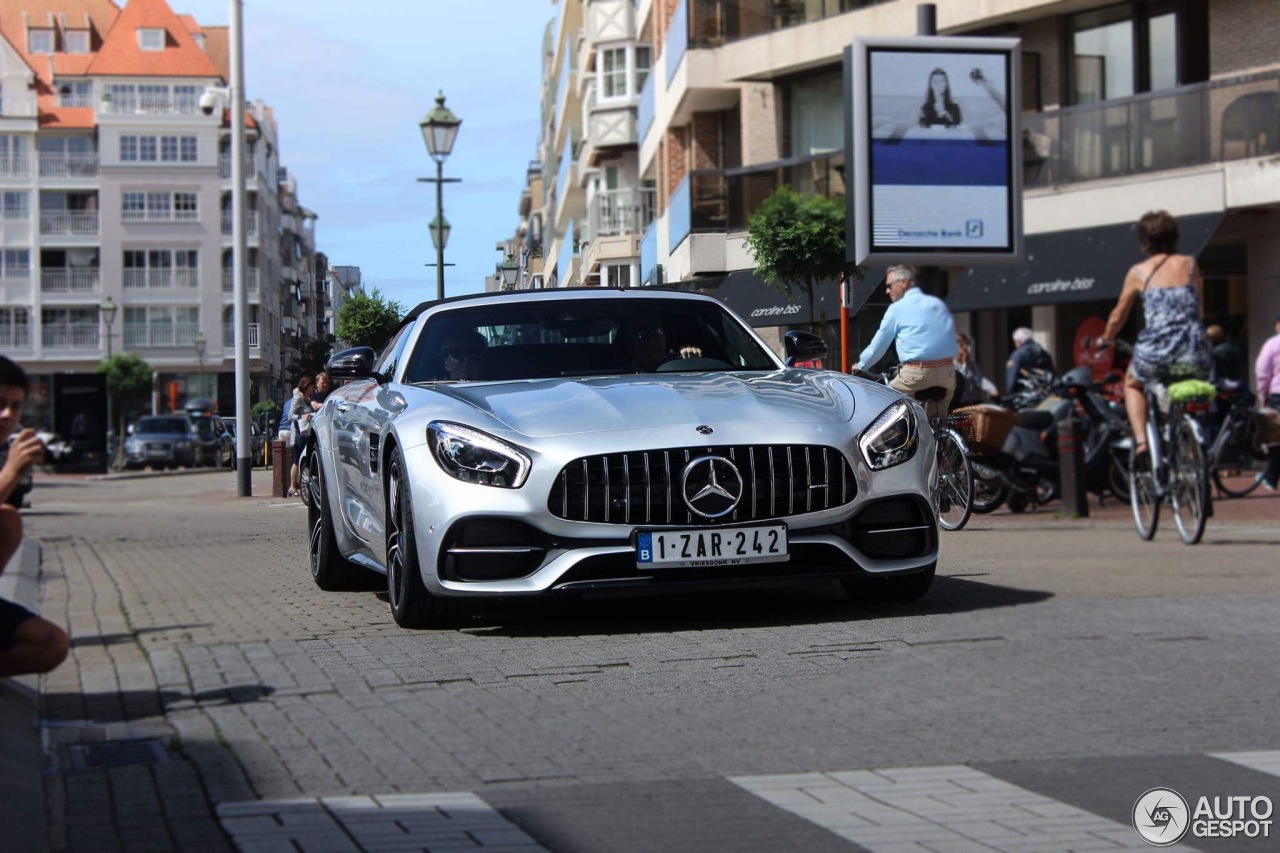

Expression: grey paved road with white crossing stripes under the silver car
xmin=12 ymin=471 xmax=1280 ymax=853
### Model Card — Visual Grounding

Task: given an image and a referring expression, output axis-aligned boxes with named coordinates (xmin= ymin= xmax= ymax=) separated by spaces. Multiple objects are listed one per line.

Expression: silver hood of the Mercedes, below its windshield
xmin=434 ymin=370 xmax=855 ymax=438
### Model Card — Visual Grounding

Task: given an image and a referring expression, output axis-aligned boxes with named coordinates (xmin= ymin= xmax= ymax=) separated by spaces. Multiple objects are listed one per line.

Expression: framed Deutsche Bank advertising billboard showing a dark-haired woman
xmin=846 ymin=36 xmax=1023 ymax=266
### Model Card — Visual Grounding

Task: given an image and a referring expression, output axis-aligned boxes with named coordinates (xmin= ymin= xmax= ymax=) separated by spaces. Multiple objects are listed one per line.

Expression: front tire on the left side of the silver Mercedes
xmin=387 ymin=447 xmax=458 ymax=629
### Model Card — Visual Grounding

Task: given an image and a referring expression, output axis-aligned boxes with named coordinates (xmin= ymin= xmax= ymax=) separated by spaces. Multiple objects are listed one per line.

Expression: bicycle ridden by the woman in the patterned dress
xmin=1129 ymin=379 xmax=1213 ymax=544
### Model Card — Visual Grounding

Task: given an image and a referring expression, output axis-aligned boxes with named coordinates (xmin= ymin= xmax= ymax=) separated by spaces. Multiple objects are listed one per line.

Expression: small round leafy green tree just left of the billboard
xmin=746 ymin=184 xmax=861 ymax=323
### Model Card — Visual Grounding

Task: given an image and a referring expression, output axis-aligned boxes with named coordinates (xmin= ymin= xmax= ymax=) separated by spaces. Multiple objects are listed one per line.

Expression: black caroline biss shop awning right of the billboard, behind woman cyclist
xmin=947 ymin=213 xmax=1222 ymax=311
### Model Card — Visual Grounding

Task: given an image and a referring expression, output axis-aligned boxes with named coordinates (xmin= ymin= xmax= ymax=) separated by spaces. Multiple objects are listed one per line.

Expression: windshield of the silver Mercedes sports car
xmin=404 ymin=298 xmax=777 ymax=382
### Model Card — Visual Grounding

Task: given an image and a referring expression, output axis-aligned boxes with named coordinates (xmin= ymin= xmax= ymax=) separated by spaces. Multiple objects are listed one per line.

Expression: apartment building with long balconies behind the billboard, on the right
xmin=516 ymin=0 xmax=1280 ymax=375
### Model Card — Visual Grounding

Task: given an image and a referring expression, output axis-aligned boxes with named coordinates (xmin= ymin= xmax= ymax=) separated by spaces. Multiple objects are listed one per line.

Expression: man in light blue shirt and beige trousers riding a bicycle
xmin=854 ymin=266 xmax=957 ymax=400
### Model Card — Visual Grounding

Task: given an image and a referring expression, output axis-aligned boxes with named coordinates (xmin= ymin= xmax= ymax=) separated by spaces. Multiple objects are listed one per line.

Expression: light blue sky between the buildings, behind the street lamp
xmin=176 ymin=0 xmax=559 ymax=310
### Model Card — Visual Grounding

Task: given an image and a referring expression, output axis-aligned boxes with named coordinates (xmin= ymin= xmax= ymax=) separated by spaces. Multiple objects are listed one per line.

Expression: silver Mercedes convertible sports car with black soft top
xmin=303 ymin=288 xmax=938 ymax=628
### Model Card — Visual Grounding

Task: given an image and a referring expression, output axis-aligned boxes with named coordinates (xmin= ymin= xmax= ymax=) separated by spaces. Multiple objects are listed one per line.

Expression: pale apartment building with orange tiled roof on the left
xmin=0 ymin=0 xmax=320 ymax=458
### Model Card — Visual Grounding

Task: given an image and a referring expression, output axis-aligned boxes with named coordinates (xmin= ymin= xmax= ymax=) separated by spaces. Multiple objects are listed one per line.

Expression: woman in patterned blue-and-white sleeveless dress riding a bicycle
xmin=1097 ymin=210 xmax=1212 ymax=453
